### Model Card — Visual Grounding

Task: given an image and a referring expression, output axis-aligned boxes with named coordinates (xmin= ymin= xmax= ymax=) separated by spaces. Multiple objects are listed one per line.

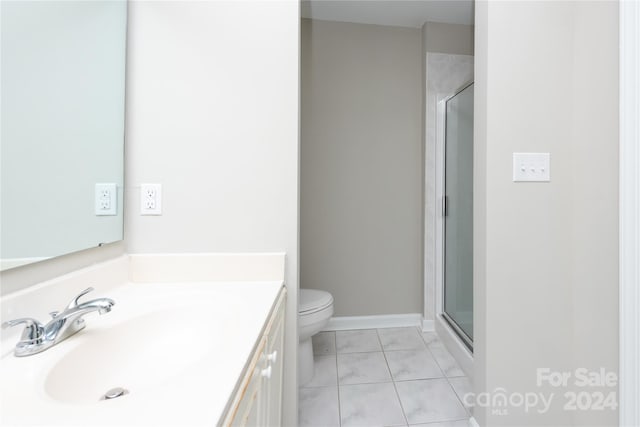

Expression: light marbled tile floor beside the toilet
xmin=299 ymin=328 xmax=473 ymax=427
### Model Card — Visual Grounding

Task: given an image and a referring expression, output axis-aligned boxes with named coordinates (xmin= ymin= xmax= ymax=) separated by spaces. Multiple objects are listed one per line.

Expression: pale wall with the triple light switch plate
xmin=474 ymin=2 xmax=618 ymax=426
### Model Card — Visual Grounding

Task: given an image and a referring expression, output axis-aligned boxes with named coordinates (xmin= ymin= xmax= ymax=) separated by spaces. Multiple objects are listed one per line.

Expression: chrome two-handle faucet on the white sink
xmin=2 ymin=288 xmax=115 ymax=357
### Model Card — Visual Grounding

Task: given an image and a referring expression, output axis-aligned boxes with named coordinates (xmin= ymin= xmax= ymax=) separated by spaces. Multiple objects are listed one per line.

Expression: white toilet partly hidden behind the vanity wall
xmin=298 ymin=289 xmax=333 ymax=385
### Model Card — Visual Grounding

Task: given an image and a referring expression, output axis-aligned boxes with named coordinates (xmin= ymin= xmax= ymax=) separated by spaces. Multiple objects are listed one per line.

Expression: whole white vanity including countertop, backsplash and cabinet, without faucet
xmin=0 ymin=253 xmax=285 ymax=427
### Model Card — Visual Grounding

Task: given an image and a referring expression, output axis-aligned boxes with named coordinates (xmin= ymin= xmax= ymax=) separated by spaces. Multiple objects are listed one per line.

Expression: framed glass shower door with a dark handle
xmin=443 ymin=83 xmax=473 ymax=347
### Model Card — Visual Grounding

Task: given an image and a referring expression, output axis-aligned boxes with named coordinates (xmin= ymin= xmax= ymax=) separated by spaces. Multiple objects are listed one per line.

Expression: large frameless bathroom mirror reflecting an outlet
xmin=0 ymin=0 xmax=127 ymax=270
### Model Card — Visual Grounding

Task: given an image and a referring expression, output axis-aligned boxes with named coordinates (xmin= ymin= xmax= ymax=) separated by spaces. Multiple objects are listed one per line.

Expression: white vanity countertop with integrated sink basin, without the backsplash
xmin=0 ymin=256 xmax=283 ymax=426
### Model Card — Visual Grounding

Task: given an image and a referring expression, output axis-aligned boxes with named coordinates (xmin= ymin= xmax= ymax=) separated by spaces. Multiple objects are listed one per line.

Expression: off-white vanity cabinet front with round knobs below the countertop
xmin=221 ymin=288 xmax=286 ymax=427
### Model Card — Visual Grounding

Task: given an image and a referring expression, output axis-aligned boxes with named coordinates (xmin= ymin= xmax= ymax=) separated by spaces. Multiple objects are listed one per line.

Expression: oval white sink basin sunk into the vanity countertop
xmin=44 ymin=307 xmax=214 ymax=403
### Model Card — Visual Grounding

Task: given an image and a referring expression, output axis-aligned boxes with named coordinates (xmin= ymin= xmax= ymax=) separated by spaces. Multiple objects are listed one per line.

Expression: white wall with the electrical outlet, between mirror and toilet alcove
xmin=125 ymin=0 xmax=299 ymax=425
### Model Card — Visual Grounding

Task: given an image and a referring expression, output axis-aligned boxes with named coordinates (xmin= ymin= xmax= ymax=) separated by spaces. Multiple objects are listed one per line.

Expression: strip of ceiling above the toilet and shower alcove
xmin=301 ymin=0 xmax=473 ymax=28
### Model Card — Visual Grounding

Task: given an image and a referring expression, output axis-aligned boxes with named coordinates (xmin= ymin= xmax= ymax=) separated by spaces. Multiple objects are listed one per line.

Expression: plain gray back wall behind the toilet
xmin=300 ymin=19 xmax=423 ymax=316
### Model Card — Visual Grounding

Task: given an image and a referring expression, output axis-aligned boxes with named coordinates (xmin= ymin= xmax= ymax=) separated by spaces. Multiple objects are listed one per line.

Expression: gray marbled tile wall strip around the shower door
xmin=424 ymin=53 xmax=473 ymax=320
